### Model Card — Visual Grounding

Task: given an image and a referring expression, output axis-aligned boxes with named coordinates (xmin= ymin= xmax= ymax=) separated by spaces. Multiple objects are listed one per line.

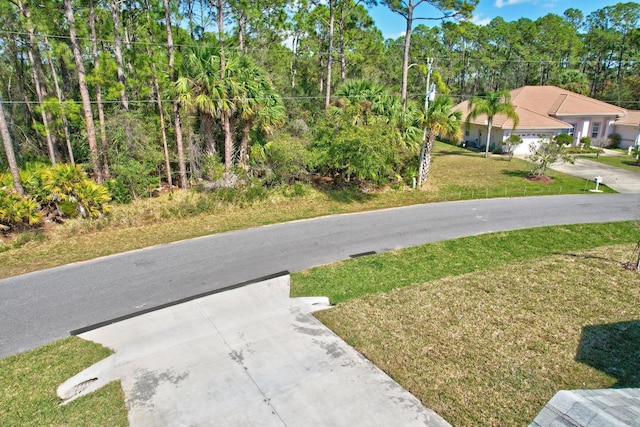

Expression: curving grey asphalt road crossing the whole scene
xmin=0 ymin=194 xmax=640 ymax=357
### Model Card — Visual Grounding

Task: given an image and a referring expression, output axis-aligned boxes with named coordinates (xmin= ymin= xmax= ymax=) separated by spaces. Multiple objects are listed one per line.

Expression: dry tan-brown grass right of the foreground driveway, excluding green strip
xmin=312 ymin=246 xmax=640 ymax=426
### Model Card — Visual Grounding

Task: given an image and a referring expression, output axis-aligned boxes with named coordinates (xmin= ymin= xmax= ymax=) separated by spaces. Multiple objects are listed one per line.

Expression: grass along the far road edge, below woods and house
xmin=0 ymin=143 xmax=611 ymax=278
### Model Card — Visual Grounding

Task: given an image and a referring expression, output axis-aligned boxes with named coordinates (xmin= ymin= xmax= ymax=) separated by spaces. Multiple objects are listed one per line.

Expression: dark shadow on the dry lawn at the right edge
xmin=576 ymin=320 xmax=640 ymax=388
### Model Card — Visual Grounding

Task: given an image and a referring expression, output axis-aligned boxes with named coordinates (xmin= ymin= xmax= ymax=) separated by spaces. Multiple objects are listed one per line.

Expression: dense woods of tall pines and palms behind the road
xmin=0 ymin=0 xmax=640 ymax=201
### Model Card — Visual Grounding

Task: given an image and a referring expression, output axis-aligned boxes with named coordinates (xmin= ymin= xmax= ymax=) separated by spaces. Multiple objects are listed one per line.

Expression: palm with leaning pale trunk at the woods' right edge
xmin=418 ymin=95 xmax=462 ymax=185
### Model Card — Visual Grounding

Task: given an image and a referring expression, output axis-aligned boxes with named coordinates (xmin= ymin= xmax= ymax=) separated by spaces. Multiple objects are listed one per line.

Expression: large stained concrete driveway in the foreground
xmin=58 ymin=275 xmax=450 ymax=427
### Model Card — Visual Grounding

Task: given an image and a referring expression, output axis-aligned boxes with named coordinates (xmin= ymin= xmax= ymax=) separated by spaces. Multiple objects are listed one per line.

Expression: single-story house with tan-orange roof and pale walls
xmin=454 ymin=86 xmax=627 ymax=154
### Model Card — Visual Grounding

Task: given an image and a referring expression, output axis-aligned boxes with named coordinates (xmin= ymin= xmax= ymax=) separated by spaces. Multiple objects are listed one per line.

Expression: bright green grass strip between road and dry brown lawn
xmin=291 ymin=221 xmax=639 ymax=304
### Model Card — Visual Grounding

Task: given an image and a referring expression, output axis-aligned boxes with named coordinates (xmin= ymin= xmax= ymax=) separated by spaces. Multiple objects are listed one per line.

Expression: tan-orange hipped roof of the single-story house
xmin=455 ymin=86 xmax=627 ymax=129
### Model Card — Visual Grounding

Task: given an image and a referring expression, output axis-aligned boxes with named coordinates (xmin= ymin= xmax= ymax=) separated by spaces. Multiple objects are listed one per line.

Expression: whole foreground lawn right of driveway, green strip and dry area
xmin=292 ymin=222 xmax=640 ymax=426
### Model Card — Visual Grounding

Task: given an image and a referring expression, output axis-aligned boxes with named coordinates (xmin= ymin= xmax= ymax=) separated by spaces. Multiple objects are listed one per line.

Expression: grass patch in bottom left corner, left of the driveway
xmin=0 ymin=337 xmax=128 ymax=426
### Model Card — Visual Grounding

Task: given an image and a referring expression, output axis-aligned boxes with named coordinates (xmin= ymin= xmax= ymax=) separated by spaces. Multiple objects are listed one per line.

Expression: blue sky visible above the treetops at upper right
xmin=369 ymin=0 xmax=626 ymax=39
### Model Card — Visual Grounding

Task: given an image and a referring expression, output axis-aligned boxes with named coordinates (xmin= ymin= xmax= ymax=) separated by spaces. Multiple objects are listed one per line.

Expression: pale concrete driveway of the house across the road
xmin=551 ymin=158 xmax=640 ymax=194
